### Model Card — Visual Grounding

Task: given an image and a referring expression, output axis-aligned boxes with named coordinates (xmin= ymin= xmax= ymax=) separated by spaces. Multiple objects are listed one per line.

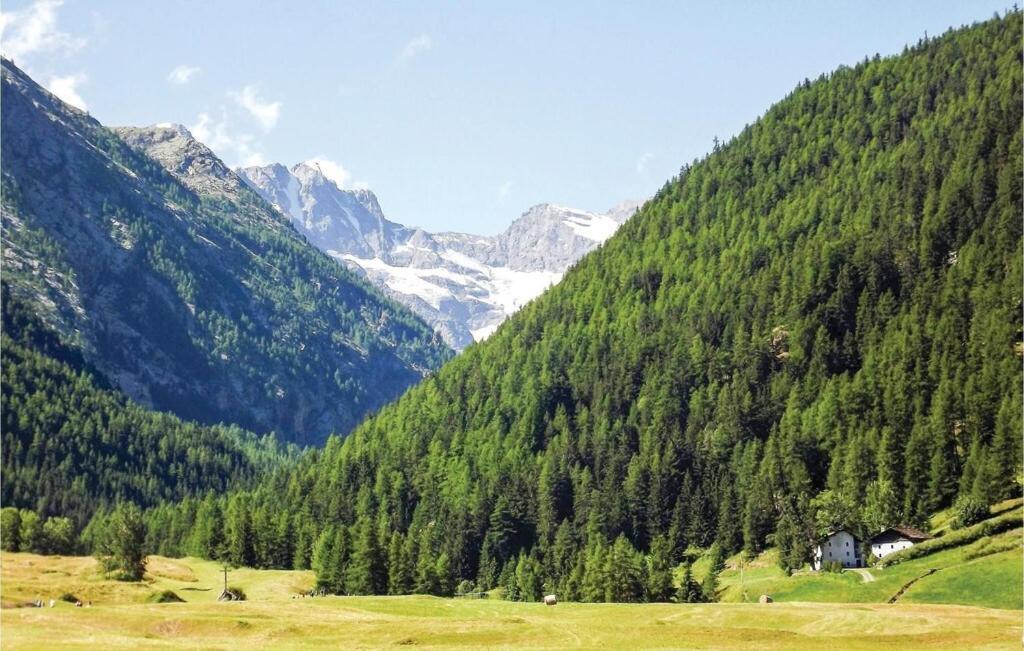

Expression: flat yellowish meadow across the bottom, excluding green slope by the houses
xmin=0 ymin=553 xmax=1024 ymax=649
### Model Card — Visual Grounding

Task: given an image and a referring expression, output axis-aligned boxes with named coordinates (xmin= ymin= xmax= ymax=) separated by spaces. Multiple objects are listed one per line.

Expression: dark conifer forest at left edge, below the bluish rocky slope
xmin=0 ymin=285 xmax=298 ymax=527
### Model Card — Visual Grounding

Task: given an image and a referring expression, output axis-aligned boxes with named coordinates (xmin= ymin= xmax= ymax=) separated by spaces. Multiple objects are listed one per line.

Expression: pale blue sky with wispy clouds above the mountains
xmin=2 ymin=0 xmax=1009 ymax=234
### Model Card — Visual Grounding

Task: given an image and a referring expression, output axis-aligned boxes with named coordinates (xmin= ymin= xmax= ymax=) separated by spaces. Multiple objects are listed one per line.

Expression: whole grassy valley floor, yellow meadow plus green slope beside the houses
xmin=0 ymin=501 xmax=1024 ymax=650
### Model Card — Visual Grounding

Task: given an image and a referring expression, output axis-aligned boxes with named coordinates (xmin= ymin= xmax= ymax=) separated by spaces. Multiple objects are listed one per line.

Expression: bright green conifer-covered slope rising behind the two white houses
xmin=153 ymin=12 xmax=1022 ymax=601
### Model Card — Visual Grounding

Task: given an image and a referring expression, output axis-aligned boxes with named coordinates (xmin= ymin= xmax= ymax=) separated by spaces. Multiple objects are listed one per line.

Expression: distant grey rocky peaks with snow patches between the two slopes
xmin=238 ymin=161 xmax=639 ymax=350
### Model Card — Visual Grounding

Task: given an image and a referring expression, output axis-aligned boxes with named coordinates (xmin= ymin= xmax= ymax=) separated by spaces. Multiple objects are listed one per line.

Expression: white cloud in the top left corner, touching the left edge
xmin=0 ymin=0 xmax=86 ymax=64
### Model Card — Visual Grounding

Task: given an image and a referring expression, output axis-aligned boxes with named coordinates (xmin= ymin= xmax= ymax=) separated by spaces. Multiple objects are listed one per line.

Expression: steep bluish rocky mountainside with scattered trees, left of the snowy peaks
xmin=0 ymin=59 xmax=451 ymax=444
